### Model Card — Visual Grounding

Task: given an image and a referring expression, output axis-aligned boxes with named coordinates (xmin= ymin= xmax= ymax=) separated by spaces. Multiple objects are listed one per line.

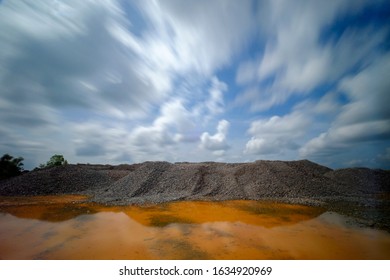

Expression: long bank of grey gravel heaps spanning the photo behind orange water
xmin=0 ymin=160 xmax=390 ymax=230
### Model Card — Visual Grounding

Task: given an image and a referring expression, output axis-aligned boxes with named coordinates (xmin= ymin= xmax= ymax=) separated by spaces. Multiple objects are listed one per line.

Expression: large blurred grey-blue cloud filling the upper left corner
xmin=0 ymin=1 xmax=169 ymax=121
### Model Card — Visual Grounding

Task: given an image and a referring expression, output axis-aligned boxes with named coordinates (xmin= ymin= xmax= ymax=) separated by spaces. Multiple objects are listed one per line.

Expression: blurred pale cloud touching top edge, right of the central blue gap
xmin=258 ymin=1 xmax=360 ymax=88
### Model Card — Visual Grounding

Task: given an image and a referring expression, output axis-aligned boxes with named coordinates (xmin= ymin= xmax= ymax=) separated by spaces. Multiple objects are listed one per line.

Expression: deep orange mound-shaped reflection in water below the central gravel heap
xmin=123 ymin=201 xmax=324 ymax=228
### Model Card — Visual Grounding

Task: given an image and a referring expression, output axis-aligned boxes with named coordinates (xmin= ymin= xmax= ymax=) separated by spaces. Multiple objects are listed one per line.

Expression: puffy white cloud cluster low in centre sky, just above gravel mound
xmin=124 ymin=74 xmax=229 ymax=160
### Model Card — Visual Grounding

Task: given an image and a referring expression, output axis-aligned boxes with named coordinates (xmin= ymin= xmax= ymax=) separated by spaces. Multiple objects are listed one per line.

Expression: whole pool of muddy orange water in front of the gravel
xmin=0 ymin=196 xmax=390 ymax=259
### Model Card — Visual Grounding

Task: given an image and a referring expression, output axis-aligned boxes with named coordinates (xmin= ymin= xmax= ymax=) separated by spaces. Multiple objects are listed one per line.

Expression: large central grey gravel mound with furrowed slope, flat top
xmin=94 ymin=160 xmax=368 ymax=204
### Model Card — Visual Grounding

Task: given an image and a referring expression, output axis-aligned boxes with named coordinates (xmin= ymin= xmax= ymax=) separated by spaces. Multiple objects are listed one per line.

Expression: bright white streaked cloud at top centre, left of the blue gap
xmin=141 ymin=1 xmax=253 ymax=76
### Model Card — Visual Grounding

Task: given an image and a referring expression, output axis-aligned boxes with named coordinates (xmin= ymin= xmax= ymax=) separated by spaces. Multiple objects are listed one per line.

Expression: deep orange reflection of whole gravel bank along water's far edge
xmin=0 ymin=198 xmax=324 ymax=228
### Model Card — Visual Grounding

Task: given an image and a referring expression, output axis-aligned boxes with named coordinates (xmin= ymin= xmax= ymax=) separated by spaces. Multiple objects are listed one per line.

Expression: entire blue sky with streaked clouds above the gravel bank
xmin=0 ymin=0 xmax=390 ymax=169
